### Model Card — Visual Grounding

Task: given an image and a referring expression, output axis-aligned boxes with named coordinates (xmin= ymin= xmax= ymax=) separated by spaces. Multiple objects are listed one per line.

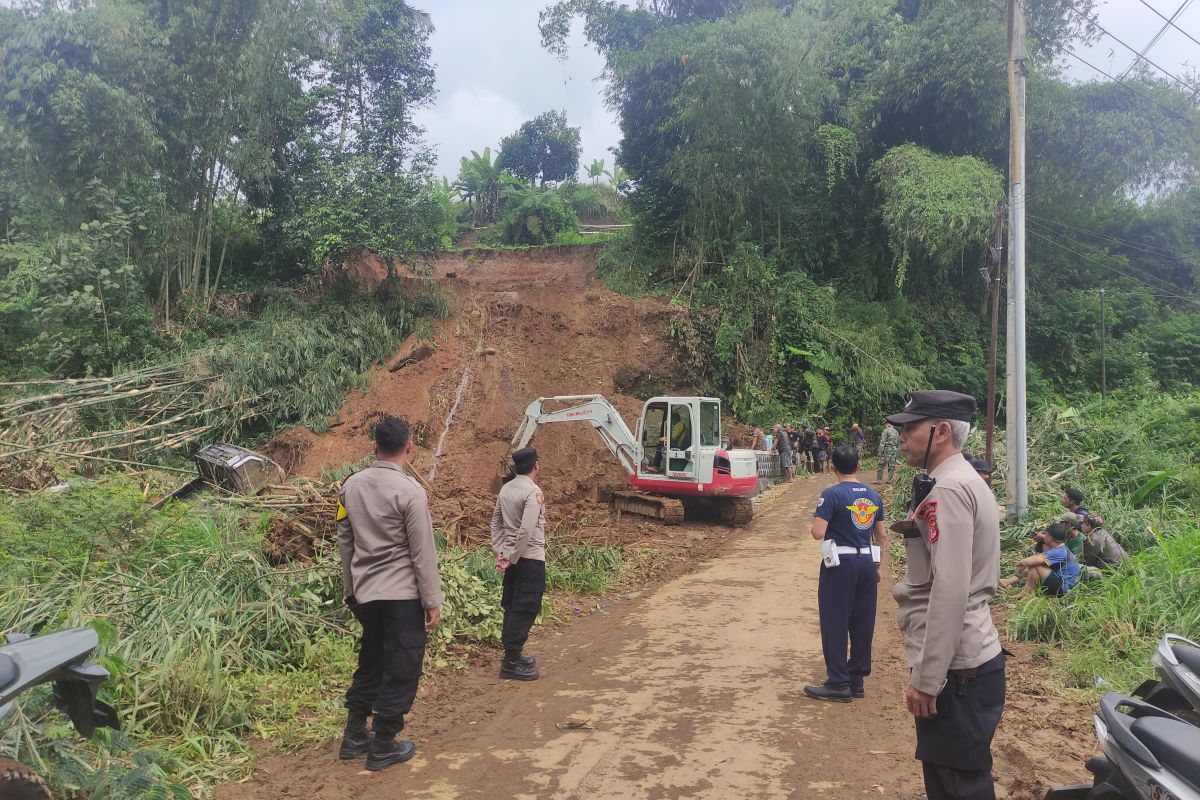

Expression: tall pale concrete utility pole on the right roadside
xmin=1006 ymin=0 xmax=1030 ymax=519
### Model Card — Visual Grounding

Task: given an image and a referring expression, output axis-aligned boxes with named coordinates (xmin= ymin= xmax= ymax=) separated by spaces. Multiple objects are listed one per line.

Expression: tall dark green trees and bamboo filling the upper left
xmin=0 ymin=0 xmax=446 ymax=375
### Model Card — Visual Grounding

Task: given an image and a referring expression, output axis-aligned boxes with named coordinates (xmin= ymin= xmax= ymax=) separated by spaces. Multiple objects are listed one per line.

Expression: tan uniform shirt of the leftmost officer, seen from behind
xmin=337 ymin=461 xmax=442 ymax=608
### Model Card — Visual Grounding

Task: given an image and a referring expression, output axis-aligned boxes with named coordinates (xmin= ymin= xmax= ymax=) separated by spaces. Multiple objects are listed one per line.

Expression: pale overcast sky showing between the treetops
xmin=413 ymin=0 xmax=1200 ymax=180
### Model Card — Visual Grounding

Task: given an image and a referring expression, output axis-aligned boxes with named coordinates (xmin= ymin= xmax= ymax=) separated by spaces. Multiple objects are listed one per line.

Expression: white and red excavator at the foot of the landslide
xmin=505 ymin=395 xmax=758 ymax=527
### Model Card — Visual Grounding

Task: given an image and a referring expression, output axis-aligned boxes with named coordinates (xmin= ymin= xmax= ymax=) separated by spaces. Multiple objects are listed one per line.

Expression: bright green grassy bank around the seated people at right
xmin=1003 ymin=392 xmax=1200 ymax=691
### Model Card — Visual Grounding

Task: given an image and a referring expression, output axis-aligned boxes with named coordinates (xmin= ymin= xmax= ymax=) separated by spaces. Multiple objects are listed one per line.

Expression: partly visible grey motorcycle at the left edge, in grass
xmin=0 ymin=627 xmax=119 ymax=800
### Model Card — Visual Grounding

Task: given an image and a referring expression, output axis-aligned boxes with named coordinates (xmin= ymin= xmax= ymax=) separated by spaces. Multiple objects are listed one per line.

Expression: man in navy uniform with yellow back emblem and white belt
xmin=804 ymin=445 xmax=887 ymax=703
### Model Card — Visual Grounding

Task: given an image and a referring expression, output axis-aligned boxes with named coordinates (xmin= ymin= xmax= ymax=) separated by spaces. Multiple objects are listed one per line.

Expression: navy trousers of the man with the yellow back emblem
xmin=817 ymin=555 xmax=878 ymax=686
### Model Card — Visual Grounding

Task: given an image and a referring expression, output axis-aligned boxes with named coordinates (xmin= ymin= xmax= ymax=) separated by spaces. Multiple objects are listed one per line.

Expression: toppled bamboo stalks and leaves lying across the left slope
xmin=0 ymin=278 xmax=449 ymax=472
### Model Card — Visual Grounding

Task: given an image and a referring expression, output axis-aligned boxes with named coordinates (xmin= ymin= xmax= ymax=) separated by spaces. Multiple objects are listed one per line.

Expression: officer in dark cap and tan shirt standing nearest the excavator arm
xmin=492 ymin=447 xmax=546 ymax=680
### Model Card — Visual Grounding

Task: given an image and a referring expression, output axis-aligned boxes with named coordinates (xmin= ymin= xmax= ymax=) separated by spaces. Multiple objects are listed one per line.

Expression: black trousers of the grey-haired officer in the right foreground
xmin=917 ymin=654 xmax=1004 ymax=800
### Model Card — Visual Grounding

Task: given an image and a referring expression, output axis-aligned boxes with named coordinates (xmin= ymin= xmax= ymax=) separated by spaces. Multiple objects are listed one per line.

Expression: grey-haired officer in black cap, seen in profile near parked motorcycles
xmin=888 ymin=391 xmax=1004 ymax=800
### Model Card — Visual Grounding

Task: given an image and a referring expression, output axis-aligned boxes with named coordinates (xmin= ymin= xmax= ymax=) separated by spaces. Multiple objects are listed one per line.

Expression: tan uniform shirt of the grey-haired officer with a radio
xmin=892 ymin=453 xmax=1000 ymax=694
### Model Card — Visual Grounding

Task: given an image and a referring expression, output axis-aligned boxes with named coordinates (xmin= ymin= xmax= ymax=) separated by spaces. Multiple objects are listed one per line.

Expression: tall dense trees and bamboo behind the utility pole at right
xmin=540 ymin=0 xmax=1200 ymax=428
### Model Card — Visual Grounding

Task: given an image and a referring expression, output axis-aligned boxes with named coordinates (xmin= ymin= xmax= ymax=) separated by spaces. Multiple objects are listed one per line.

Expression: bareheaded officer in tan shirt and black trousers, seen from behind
xmin=337 ymin=416 xmax=442 ymax=771
